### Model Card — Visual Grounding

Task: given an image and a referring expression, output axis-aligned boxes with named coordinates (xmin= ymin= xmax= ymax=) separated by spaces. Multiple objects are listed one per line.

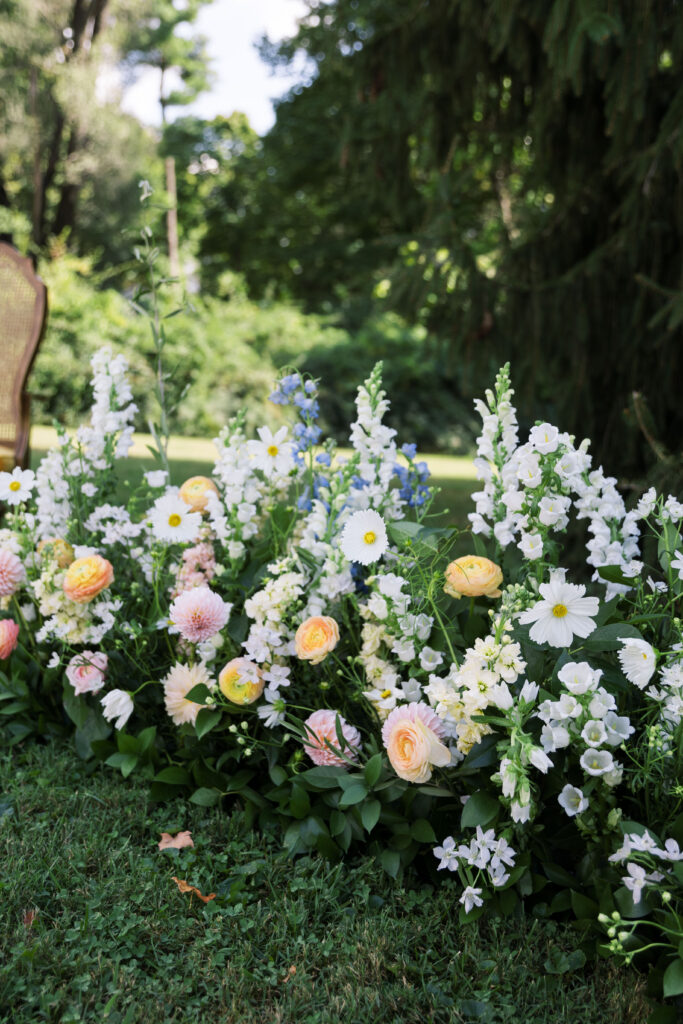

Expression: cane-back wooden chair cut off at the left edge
xmin=0 ymin=242 xmax=47 ymax=469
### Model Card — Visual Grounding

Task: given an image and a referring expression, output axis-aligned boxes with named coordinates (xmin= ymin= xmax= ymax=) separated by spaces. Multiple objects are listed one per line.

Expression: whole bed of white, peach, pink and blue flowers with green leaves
xmin=0 ymin=351 xmax=683 ymax=1011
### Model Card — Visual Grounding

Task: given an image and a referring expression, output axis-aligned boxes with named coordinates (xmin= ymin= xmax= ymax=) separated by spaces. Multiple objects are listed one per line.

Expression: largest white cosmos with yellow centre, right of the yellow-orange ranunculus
xmin=519 ymin=573 xmax=599 ymax=647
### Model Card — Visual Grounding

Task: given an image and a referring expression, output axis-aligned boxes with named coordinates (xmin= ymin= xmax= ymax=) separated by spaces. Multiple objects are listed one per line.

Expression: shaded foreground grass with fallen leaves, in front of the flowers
xmin=0 ymin=742 xmax=647 ymax=1024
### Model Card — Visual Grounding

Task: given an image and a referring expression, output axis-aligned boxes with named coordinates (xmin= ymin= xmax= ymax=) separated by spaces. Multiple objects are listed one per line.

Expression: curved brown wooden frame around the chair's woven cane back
xmin=0 ymin=242 xmax=47 ymax=469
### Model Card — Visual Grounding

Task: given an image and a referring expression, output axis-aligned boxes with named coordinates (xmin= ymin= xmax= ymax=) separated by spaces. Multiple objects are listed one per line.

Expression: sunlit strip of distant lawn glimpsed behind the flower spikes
xmin=31 ymin=426 xmax=479 ymax=527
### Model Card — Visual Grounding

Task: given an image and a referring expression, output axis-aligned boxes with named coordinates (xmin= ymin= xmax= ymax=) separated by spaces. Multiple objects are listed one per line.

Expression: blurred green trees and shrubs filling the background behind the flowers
xmin=0 ymin=0 xmax=683 ymax=489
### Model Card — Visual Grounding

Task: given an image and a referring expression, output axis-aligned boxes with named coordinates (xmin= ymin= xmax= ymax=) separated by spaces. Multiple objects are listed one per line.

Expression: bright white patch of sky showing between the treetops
xmin=122 ymin=0 xmax=307 ymax=134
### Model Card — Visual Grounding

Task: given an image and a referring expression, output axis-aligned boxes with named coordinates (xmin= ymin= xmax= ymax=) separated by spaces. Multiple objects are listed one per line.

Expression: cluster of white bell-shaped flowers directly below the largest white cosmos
xmin=537 ymin=662 xmax=635 ymax=802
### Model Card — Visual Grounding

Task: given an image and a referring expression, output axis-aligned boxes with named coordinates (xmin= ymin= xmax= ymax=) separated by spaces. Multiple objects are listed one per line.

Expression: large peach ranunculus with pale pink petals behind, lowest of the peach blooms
xmin=382 ymin=701 xmax=451 ymax=782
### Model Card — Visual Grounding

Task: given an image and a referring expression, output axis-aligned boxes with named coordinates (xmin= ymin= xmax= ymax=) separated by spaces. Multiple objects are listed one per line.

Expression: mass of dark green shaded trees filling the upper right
xmin=220 ymin=0 xmax=683 ymax=474
